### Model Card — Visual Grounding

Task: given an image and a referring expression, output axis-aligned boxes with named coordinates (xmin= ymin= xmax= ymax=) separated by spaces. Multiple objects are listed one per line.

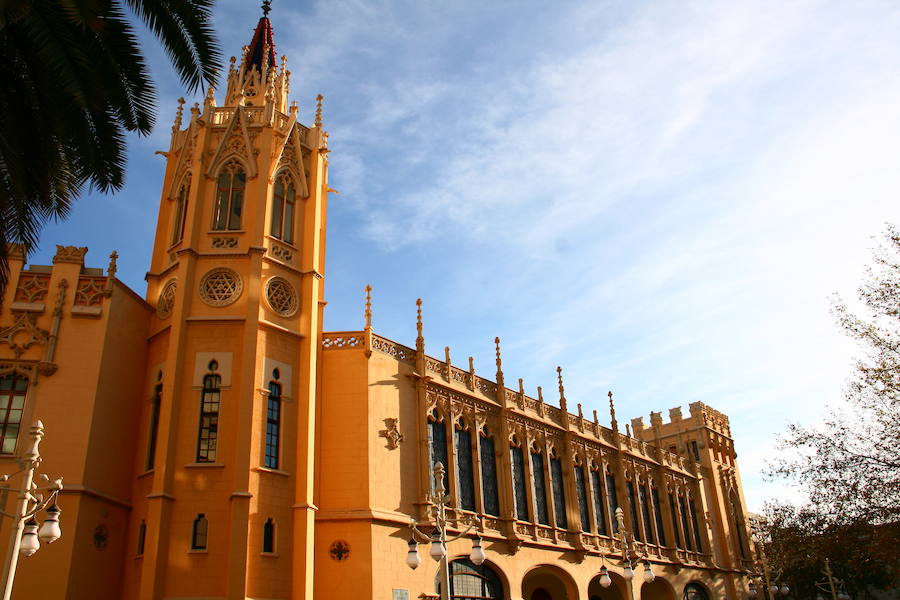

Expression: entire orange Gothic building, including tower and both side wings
xmin=0 ymin=8 xmax=751 ymax=600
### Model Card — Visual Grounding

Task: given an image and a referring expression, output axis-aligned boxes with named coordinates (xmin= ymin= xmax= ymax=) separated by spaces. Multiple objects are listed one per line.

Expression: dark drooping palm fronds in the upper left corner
xmin=0 ymin=0 xmax=220 ymax=290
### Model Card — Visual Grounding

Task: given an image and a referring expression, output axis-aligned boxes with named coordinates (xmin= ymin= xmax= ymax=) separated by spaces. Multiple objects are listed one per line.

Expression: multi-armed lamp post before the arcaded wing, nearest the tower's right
xmin=406 ymin=463 xmax=485 ymax=600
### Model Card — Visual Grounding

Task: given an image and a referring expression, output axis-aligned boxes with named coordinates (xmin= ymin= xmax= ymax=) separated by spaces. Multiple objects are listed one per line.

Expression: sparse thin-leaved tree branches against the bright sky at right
xmin=770 ymin=225 xmax=900 ymax=524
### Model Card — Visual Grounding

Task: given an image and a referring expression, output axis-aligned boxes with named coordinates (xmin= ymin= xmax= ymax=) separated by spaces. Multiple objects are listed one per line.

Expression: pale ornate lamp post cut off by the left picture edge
xmin=0 ymin=421 xmax=62 ymax=600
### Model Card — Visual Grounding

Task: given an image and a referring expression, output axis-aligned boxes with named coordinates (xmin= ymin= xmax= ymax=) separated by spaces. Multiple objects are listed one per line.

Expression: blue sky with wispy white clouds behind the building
xmin=33 ymin=0 xmax=900 ymax=510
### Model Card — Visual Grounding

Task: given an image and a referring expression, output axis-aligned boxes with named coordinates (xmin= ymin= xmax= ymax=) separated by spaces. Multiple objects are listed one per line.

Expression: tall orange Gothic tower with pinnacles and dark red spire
xmin=123 ymin=7 xmax=328 ymax=600
